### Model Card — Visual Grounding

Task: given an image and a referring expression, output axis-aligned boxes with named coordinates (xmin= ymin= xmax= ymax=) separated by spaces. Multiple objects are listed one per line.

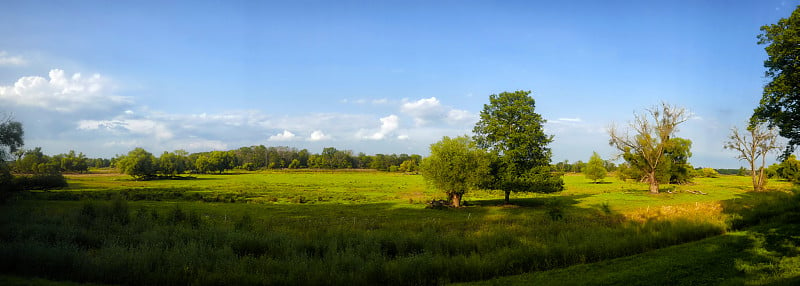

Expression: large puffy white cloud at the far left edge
xmin=0 ymin=69 xmax=132 ymax=113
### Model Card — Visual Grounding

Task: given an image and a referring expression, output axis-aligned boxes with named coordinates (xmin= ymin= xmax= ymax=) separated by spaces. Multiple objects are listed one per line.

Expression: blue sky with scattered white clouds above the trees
xmin=0 ymin=0 xmax=800 ymax=168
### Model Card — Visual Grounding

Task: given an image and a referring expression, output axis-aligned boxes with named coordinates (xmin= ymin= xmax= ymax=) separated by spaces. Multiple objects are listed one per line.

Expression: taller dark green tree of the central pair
xmin=472 ymin=91 xmax=564 ymax=204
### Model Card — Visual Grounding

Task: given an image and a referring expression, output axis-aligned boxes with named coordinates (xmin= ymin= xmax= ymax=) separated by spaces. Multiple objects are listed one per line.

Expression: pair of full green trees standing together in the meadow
xmin=421 ymin=91 xmax=564 ymax=207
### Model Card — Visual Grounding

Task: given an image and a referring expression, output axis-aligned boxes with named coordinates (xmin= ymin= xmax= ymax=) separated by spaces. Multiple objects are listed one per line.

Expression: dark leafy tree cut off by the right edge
xmin=751 ymin=6 xmax=800 ymax=157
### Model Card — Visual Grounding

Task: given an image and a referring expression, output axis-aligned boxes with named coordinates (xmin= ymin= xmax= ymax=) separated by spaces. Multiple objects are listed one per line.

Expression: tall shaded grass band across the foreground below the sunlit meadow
xmin=0 ymin=198 xmax=724 ymax=285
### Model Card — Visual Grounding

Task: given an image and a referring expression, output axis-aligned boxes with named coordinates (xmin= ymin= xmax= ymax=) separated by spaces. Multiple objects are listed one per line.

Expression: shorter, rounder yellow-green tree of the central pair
xmin=420 ymin=136 xmax=490 ymax=207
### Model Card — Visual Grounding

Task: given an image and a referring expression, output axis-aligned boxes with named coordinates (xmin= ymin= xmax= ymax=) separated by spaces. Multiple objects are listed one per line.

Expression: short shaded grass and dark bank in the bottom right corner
xmin=462 ymin=188 xmax=800 ymax=285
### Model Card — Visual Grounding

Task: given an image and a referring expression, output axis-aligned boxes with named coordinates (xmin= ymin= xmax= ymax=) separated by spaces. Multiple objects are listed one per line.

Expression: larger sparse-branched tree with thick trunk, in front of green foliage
xmin=608 ymin=102 xmax=689 ymax=194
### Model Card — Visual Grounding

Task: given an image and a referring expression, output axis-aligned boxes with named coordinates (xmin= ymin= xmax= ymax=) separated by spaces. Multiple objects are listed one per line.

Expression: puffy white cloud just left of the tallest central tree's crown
xmin=400 ymin=97 xmax=475 ymax=126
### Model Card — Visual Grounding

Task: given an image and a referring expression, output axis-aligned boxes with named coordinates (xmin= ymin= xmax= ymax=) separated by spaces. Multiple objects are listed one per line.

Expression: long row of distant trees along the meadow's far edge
xmin=111 ymin=145 xmax=422 ymax=179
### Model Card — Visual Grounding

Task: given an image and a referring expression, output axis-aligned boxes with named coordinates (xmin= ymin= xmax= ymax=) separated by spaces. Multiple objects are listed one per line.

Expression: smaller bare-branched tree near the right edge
xmin=725 ymin=123 xmax=782 ymax=192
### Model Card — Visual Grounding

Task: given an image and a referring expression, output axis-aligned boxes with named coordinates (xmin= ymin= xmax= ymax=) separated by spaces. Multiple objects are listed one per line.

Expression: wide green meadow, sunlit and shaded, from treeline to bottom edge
xmin=0 ymin=171 xmax=794 ymax=285
